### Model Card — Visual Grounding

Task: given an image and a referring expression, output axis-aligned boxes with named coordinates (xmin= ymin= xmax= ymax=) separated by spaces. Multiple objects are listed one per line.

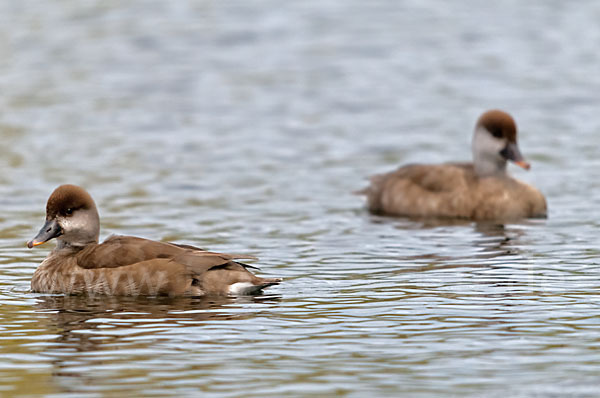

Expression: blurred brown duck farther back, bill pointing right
xmin=358 ymin=109 xmax=547 ymax=222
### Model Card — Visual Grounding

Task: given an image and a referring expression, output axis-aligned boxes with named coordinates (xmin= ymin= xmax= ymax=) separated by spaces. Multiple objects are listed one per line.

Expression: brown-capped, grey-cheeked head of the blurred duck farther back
xmin=472 ymin=109 xmax=530 ymax=176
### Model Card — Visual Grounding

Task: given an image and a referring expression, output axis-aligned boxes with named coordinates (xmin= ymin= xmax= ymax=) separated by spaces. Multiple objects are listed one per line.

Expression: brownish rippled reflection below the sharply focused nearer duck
xmin=36 ymin=295 xmax=280 ymax=392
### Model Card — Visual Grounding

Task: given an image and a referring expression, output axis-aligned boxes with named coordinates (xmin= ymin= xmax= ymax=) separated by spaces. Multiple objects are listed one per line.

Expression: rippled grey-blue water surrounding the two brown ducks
xmin=0 ymin=0 xmax=600 ymax=397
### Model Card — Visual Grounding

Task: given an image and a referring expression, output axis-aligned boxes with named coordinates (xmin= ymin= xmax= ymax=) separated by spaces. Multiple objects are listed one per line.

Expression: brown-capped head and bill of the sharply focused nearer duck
xmin=27 ymin=185 xmax=100 ymax=248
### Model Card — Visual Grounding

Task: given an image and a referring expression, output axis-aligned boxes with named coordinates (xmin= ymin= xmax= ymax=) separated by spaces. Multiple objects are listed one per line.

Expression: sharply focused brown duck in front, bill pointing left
xmin=27 ymin=184 xmax=282 ymax=296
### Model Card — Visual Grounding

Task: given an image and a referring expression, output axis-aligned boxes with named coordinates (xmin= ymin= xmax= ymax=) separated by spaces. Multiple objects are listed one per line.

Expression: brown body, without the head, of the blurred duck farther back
xmin=363 ymin=163 xmax=546 ymax=220
